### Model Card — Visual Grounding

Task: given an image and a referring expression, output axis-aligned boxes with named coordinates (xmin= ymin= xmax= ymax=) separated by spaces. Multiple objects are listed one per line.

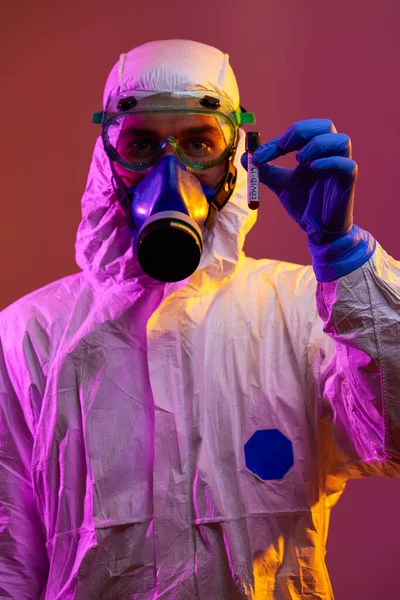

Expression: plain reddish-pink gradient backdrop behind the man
xmin=0 ymin=0 xmax=400 ymax=600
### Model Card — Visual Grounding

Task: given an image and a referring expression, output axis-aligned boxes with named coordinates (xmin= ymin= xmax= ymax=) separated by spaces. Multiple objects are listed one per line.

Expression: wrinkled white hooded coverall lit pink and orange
xmin=0 ymin=40 xmax=400 ymax=600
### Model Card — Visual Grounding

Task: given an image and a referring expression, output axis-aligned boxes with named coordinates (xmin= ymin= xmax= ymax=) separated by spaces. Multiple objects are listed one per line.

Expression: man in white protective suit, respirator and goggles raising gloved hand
xmin=0 ymin=40 xmax=400 ymax=600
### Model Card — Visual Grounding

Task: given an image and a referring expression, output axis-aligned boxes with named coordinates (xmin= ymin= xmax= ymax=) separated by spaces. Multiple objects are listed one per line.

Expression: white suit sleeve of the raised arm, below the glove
xmin=309 ymin=244 xmax=400 ymax=478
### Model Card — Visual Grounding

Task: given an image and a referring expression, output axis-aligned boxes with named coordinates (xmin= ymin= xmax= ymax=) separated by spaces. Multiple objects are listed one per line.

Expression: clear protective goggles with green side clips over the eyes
xmin=93 ymin=90 xmax=255 ymax=171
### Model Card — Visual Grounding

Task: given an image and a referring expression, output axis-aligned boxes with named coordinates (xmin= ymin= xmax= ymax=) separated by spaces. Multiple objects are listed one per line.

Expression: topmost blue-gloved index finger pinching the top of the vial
xmin=254 ymin=119 xmax=337 ymax=163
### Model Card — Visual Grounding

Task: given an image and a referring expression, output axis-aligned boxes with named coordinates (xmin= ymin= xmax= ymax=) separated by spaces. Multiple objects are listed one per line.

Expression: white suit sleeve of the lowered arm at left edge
xmin=0 ymin=330 xmax=49 ymax=600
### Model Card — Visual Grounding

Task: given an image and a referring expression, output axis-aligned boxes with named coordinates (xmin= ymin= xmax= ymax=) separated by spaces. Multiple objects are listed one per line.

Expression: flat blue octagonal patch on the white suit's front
xmin=244 ymin=429 xmax=294 ymax=480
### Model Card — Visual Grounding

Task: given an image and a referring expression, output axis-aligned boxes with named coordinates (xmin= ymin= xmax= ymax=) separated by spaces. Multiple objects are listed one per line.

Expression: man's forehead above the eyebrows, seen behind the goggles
xmin=122 ymin=113 xmax=225 ymax=136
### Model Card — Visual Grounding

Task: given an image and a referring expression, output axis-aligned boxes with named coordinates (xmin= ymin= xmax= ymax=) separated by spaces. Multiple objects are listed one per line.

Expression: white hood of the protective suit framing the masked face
xmin=76 ymin=40 xmax=256 ymax=289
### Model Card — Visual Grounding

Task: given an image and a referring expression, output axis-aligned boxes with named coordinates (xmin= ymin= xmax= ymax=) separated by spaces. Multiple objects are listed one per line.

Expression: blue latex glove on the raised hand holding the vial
xmin=241 ymin=119 xmax=376 ymax=281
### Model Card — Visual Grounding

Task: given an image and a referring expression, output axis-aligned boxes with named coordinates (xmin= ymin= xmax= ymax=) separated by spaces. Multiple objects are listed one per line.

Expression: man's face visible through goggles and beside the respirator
xmin=114 ymin=113 xmax=231 ymax=187
